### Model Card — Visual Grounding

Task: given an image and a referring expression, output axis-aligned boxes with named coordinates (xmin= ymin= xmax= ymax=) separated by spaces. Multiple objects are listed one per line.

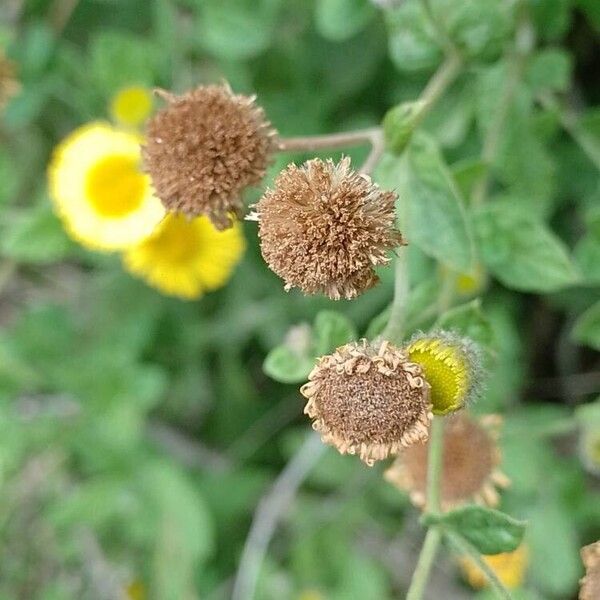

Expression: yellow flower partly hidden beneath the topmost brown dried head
xmin=123 ymin=213 xmax=245 ymax=299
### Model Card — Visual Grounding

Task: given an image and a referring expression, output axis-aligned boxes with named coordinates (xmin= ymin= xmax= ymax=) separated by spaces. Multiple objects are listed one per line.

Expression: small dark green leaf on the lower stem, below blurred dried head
xmin=434 ymin=505 xmax=526 ymax=554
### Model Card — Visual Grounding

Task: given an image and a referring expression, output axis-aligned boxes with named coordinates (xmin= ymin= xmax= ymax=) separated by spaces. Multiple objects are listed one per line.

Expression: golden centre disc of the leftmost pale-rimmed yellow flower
xmin=85 ymin=156 xmax=148 ymax=218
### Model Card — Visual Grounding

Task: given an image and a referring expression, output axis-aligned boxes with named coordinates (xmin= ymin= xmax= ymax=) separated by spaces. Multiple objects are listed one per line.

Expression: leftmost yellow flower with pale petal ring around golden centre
xmin=48 ymin=123 xmax=165 ymax=250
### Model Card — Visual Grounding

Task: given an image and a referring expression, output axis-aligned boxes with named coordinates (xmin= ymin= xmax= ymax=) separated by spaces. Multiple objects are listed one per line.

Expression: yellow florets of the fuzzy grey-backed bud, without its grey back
xmin=408 ymin=338 xmax=469 ymax=415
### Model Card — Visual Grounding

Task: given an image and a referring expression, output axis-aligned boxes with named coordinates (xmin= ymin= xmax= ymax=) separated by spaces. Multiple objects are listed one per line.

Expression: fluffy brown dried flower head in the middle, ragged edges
xmin=250 ymin=158 xmax=403 ymax=300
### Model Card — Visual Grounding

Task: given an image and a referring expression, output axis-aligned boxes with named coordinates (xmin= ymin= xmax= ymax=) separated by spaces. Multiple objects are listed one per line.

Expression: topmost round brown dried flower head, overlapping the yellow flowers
xmin=143 ymin=85 xmax=276 ymax=229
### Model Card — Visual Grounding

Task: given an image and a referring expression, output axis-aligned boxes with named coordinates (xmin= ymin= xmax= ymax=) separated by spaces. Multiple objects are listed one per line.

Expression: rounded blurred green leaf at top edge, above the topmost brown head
xmin=198 ymin=0 xmax=282 ymax=60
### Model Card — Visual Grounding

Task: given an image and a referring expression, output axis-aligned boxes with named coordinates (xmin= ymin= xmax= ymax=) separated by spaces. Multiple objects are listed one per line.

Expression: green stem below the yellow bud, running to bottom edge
xmin=406 ymin=417 xmax=444 ymax=600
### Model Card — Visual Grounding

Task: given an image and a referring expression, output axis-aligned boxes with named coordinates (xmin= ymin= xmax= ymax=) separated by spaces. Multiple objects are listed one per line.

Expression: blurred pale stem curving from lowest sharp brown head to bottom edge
xmin=231 ymin=432 xmax=325 ymax=600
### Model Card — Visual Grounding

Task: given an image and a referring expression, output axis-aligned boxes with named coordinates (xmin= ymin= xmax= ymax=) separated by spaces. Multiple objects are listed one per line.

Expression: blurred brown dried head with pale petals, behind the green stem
xmin=385 ymin=413 xmax=509 ymax=510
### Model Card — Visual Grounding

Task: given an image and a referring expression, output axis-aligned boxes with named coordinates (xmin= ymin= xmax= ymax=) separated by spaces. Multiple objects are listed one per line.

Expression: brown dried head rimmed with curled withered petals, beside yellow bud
xmin=301 ymin=340 xmax=431 ymax=465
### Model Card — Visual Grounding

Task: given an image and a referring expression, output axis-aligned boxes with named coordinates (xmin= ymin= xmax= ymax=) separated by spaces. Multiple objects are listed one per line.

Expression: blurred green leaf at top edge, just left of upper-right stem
xmin=386 ymin=0 xmax=442 ymax=72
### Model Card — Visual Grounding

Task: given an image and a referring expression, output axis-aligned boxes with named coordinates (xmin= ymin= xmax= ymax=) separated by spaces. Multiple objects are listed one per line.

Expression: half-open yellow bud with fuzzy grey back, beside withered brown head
xmin=406 ymin=331 xmax=483 ymax=415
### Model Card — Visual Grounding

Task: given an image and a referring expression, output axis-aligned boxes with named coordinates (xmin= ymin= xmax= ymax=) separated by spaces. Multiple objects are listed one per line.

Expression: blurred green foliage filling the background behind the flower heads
xmin=0 ymin=0 xmax=600 ymax=600
